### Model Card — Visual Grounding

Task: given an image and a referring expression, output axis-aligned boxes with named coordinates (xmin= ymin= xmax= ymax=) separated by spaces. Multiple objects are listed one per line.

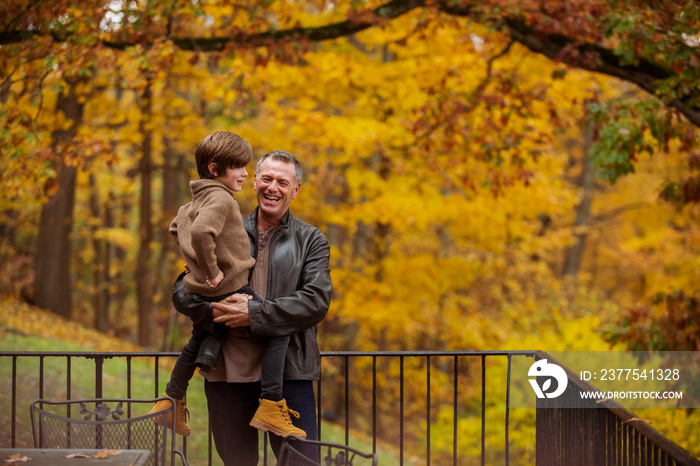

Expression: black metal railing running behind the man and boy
xmin=0 ymin=351 xmax=700 ymax=466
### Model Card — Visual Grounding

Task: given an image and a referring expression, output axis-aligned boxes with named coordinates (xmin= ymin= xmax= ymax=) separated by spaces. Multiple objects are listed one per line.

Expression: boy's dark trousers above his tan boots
xmin=165 ymin=285 xmax=289 ymax=400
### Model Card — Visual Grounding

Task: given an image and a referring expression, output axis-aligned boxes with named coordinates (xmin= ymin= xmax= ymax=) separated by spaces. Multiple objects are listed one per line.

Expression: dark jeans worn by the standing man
xmin=204 ymin=380 xmax=319 ymax=466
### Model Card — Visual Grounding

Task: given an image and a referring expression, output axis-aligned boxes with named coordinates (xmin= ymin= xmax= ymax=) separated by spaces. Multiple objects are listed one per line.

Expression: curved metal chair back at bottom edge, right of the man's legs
xmin=277 ymin=435 xmax=379 ymax=466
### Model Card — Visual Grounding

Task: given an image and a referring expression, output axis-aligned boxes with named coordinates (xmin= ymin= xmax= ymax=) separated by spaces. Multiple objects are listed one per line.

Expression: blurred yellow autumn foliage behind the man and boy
xmin=0 ymin=0 xmax=700 ymax=458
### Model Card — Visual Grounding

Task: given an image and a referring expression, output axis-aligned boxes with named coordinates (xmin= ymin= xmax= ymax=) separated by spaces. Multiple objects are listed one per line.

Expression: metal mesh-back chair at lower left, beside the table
xmin=30 ymin=397 xmax=187 ymax=466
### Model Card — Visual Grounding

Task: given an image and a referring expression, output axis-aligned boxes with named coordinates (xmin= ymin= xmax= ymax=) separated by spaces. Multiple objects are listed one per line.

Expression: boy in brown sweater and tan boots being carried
xmin=151 ymin=131 xmax=306 ymax=438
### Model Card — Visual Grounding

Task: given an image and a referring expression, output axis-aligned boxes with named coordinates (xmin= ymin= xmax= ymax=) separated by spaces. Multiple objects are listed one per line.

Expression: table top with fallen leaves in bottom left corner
xmin=0 ymin=448 xmax=151 ymax=466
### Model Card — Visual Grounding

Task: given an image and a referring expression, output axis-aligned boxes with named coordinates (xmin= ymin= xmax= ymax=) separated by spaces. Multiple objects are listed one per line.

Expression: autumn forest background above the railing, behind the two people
xmin=0 ymin=0 xmax=700 ymax=462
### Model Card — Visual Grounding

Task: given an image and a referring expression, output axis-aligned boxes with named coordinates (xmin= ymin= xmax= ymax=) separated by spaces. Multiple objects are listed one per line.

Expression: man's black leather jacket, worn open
xmin=173 ymin=208 xmax=333 ymax=380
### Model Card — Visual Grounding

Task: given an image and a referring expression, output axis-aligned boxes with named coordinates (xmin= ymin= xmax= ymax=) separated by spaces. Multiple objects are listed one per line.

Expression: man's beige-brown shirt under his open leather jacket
xmin=200 ymin=228 xmax=275 ymax=383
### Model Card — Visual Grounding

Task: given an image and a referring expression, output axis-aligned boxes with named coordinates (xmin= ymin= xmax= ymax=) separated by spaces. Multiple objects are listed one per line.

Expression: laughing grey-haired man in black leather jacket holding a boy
xmin=173 ymin=151 xmax=332 ymax=466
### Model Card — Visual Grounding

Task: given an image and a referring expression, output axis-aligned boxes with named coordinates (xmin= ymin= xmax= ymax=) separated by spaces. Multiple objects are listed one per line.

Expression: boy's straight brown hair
xmin=194 ymin=131 xmax=253 ymax=179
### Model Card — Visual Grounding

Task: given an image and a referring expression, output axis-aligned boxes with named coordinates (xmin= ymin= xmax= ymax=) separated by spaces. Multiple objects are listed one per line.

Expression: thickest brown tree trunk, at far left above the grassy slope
xmin=33 ymin=82 xmax=84 ymax=318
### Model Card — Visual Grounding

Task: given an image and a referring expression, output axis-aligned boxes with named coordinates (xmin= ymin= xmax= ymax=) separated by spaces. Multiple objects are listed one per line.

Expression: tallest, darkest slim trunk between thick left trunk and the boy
xmin=136 ymin=83 xmax=154 ymax=347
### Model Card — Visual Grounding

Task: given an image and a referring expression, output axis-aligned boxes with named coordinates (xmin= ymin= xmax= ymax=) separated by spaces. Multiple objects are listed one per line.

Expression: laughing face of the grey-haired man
xmin=253 ymin=158 xmax=301 ymax=221
